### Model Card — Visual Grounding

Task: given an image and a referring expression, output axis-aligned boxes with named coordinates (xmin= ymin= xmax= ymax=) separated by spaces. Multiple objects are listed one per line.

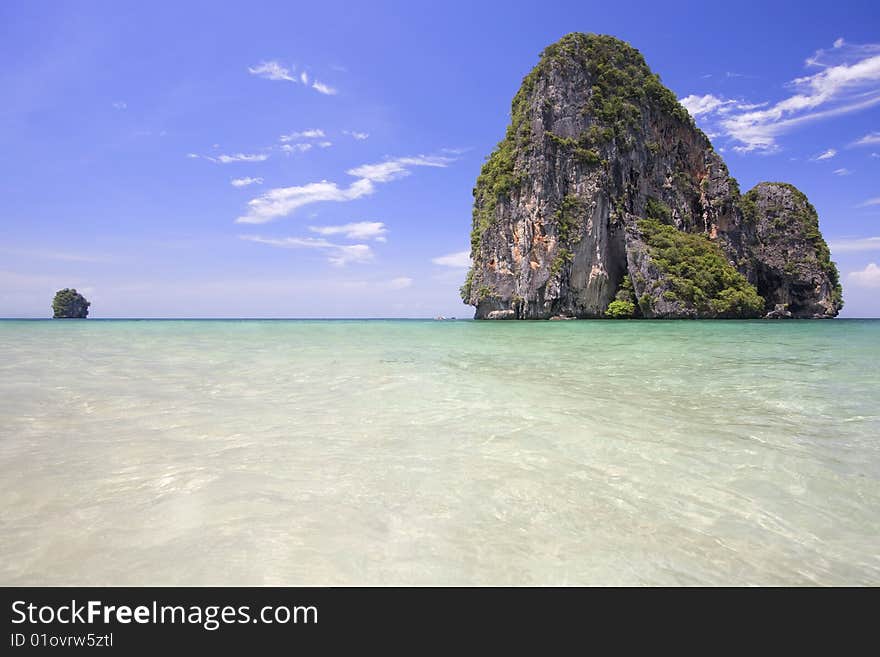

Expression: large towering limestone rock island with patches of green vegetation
xmin=462 ymin=34 xmax=841 ymax=319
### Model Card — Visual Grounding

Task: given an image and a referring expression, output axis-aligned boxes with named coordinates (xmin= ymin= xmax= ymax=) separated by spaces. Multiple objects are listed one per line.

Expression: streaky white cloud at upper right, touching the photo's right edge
xmin=681 ymin=40 xmax=880 ymax=152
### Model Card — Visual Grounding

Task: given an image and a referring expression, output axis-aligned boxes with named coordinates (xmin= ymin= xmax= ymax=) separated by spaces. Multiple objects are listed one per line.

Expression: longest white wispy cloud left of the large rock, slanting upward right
xmin=236 ymin=155 xmax=454 ymax=224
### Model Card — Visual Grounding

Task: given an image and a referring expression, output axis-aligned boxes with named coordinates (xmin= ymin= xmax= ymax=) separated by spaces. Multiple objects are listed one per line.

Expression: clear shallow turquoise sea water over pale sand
xmin=0 ymin=320 xmax=880 ymax=585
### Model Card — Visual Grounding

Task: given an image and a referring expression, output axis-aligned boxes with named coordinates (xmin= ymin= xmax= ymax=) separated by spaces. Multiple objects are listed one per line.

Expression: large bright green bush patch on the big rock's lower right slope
xmin=638 ymin=219 xmax=764 ymax=317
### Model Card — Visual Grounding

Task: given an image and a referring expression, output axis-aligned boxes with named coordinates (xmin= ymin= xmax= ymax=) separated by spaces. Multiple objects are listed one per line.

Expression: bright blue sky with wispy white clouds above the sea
xmin=0 ymin=0 xmax=880 ymax=317
